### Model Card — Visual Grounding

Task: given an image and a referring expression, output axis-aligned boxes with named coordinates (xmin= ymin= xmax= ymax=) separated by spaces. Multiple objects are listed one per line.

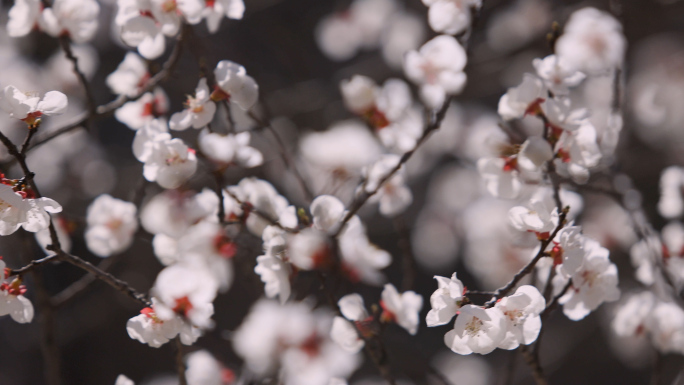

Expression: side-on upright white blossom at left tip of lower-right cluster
xmin=425 ymin=273 xmax=465 ymax=327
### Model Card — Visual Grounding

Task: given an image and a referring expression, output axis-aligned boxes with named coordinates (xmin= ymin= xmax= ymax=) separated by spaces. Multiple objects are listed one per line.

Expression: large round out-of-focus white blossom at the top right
xmin=556 ymin=7 xmax=627 ymax=74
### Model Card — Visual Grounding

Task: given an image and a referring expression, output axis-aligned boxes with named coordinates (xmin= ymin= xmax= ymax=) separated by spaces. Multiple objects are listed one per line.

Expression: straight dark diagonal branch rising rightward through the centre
xmin=333 ymin=97 xmax=451 ymax=237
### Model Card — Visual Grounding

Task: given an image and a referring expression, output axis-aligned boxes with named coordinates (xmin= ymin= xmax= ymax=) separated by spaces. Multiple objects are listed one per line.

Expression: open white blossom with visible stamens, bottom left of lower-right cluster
xmin=444 ymin=305 xmax=508 ymax=355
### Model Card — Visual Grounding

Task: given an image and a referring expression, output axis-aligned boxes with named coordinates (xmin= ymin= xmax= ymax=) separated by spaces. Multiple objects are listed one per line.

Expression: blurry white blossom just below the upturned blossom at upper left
xmin=197 ymin=130 xmax=264 ymax=168
